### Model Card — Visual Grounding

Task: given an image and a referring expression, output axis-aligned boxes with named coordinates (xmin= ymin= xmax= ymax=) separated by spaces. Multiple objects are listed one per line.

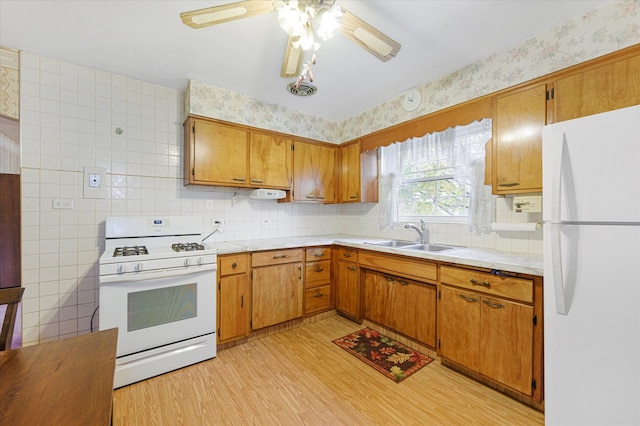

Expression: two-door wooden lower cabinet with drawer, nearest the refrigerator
xmin=438 ymin=266 xmax=541 ymax=397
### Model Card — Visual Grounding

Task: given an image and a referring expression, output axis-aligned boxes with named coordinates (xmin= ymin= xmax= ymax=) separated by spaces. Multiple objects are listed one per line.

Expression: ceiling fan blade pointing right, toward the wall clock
xmin=340 ymin=8 xmax=400 ymax=62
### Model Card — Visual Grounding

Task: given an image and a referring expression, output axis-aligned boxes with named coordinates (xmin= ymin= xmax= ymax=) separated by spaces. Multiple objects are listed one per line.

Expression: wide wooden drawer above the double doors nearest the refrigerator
xmin=440 ymin=265 xmax=533 ymax=303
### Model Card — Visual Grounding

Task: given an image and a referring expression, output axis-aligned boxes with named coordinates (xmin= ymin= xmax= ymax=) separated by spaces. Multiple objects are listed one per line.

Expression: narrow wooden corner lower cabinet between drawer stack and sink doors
xmin=334 ymin=248 xmax=362 ymax=322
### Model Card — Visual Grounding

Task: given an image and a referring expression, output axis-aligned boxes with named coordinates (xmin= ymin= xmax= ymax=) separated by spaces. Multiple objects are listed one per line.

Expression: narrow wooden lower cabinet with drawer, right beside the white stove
xmin=217 ymin=253 xmax=251 ymax=343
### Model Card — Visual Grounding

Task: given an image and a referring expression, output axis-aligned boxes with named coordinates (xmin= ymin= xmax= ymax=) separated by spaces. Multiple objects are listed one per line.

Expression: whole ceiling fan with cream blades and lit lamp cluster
xmin=180 ymin=0 xmax=400 ymax=83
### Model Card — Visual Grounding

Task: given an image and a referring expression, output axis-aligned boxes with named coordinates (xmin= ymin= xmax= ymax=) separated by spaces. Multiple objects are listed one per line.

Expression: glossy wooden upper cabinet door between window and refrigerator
xmin=491 ymin=85 xmax=547 ymax=194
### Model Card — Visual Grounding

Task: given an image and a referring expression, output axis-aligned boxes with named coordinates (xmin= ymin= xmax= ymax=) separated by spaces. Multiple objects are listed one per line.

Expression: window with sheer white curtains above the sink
xmin=380 ymin=120 xmax=491 ymax=225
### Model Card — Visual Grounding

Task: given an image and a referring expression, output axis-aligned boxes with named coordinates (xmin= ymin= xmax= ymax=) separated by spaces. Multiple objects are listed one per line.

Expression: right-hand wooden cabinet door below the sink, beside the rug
xmin=392 ymin=278 xmax=436 ymax=348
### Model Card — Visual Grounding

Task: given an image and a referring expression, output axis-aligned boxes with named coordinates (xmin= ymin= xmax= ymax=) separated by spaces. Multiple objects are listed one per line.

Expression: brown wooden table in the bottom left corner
xmin=0 ymin=328 xmax=118 ymax=425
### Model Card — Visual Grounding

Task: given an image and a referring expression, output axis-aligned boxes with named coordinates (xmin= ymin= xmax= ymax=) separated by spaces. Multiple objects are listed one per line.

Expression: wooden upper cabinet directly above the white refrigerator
xmin=554 ymin=55 xmax=640 ymax=122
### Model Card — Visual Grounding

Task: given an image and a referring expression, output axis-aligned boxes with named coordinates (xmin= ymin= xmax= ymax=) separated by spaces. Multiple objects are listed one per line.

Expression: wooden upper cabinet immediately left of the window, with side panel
xmin=339 ymin=141 xmax=378 ymax=203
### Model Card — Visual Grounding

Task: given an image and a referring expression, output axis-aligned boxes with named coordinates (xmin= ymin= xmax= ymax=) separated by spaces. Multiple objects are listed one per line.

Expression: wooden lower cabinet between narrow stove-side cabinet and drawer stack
xmin=251 ymin=249 xmax=304 ymax=330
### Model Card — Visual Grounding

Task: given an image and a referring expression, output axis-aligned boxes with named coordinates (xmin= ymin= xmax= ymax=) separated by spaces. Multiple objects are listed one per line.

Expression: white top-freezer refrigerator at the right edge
xmin=542 ymin=105 xmax=640 ymax=426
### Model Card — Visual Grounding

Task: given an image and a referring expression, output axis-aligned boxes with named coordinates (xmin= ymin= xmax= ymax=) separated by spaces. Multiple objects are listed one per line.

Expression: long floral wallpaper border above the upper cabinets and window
xmin=185 ymin=0 xmax=640 ymax=143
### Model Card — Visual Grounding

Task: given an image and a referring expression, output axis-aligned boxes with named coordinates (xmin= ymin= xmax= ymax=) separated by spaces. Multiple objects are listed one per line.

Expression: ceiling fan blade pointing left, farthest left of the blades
xmin=180 ymin=0 xmax=274 ymax=28
